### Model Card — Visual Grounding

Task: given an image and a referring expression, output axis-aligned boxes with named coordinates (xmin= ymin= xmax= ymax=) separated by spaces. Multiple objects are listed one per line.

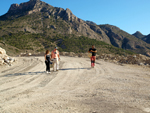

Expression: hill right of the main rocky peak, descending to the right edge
xmin=99 ymin=25 xmax=150 ymax=55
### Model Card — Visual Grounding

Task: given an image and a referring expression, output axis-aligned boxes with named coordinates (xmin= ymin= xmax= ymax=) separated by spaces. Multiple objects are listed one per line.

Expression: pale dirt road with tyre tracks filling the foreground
xmin=0 ymin=56 xmax=150 ymax=113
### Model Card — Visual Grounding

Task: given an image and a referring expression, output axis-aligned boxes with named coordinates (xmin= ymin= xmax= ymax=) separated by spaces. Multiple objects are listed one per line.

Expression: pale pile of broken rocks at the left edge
xmin=0 ymin=47 xmax=16 ymax=66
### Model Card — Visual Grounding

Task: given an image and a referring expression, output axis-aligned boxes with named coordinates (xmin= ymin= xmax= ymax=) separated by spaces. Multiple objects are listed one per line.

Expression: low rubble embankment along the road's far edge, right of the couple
xmin=60 ymin=52 xmax=150 ymax=66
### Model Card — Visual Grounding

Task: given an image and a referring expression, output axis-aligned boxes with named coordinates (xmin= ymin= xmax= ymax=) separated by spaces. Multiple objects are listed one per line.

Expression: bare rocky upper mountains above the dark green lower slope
xmin=0 ymin=0 xmax=150 ymax=54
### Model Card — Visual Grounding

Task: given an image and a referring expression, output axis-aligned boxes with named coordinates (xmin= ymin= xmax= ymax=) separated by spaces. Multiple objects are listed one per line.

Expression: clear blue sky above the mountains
xmin=0 ymin=0 xmax=150 ymax=35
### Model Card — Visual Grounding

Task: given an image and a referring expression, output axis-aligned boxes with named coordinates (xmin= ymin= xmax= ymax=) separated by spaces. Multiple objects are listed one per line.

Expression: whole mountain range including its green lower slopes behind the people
xmin=0 ymin=0 xmax=150 ymax=54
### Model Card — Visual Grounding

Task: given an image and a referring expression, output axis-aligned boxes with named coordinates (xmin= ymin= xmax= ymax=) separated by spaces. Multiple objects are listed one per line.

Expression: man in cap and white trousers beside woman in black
xmin=51 ymin=47 xmax=60 ymax=71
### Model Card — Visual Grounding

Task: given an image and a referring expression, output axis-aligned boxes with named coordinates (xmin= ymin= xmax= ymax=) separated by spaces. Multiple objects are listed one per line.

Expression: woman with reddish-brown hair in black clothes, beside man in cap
xmin=45 ymin=50 xmax=51 ymax=73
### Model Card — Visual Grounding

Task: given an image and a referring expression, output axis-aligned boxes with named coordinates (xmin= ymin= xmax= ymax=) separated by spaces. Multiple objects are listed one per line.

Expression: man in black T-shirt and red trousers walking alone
xmin=88 ymin=45 xmax=97 ymax=68
